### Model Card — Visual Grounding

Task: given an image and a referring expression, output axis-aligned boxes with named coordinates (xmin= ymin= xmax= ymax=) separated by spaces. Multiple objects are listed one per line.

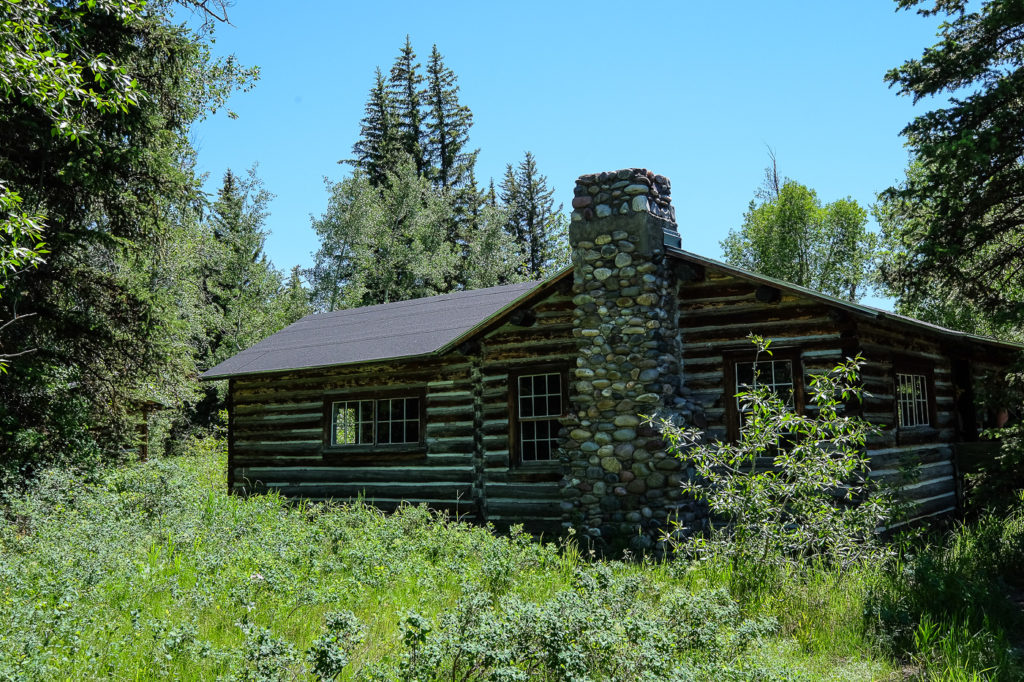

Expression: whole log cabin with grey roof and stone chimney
xmin=203 ymin=168 xmax=1021 ymax=549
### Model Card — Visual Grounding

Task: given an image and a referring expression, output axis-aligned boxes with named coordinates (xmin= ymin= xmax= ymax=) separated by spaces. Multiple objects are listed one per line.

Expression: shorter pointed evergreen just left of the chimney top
xmin=500 ymin=152 xmax=568 ymax=279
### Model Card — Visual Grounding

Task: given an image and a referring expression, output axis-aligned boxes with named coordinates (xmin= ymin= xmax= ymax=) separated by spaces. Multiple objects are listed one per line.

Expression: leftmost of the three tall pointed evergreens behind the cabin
xmin=352 ymin=69 xmax=402 ymax=186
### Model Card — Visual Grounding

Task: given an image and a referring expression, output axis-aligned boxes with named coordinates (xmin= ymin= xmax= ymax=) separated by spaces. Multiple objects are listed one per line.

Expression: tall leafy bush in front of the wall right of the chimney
xmin=649 ymin=335 xmax=897 ymax=566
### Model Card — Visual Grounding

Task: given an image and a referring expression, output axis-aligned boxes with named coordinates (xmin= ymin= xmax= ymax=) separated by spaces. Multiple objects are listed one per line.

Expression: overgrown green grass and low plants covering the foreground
xmin=0 ymin=440 xmax=1024 ymax=680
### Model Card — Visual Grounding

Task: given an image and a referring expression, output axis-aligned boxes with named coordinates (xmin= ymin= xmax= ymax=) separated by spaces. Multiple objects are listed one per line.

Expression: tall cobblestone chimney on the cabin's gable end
xmin=562 ymin=168 xmax=693 ymax=550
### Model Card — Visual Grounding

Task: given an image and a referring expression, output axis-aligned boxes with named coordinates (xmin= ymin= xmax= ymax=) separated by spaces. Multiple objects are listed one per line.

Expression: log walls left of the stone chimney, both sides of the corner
xmin=228 ymin=281 xmax=574 ymax=534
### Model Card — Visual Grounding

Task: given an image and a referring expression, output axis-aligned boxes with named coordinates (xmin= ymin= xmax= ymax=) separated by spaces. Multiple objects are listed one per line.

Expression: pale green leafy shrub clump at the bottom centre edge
xmin=366 ymin=565 xmax=777 ymax=681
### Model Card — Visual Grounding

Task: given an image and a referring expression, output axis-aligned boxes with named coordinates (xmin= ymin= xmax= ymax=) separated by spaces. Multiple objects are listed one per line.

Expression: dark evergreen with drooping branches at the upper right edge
xmin=880 ymin=0 xmax=1024 ymax=330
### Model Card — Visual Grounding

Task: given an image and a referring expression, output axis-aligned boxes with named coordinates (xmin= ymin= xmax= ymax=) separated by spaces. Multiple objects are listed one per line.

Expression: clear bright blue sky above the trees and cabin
xmin=194 ymin=0 xmax=938 ymax=304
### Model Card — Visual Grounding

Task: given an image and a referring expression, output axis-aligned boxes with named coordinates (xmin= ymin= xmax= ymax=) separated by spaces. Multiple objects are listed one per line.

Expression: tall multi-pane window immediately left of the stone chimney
xmin=515 ymin=372 xmax=564 ymax=462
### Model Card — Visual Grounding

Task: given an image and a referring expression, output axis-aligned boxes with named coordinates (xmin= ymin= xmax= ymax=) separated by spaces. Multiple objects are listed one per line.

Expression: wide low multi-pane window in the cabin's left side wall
xmin=331 ymin=396 xmax=421 ymax=447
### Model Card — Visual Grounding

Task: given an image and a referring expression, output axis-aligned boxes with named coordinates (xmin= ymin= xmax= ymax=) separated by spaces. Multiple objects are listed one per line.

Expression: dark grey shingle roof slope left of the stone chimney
xmin=202 ymin=282 xmax=540 ymax=379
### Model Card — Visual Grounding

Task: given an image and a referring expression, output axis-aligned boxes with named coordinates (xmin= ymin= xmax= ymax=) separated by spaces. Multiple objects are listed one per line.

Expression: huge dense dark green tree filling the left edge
xmin=0 ymin=0 xmax=256 ymax=464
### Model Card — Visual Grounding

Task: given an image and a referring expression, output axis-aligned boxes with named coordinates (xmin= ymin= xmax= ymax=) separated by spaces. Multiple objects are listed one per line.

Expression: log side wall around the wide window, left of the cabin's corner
xmin=228 ymin=356 xmax=480 ymax=519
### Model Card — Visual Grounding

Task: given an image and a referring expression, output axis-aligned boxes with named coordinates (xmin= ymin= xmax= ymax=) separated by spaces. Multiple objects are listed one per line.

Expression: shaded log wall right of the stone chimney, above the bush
xmin=679 ymin=262 xmax=987 ymax=519
